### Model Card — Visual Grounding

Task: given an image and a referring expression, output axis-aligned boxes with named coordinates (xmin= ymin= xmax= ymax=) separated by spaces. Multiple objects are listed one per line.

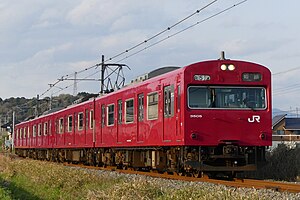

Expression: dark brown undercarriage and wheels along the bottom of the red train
xmin=16 ymin=145 xmax=265 ymax=177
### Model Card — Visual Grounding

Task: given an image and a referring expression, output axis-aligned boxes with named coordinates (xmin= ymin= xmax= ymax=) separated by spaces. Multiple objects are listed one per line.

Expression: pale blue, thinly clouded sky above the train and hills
xmin=0 ymin=0 xmax=300 ymax=111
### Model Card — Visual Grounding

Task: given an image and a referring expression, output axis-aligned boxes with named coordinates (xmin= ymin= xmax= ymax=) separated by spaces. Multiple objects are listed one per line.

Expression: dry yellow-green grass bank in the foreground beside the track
xmin=0 ymin=156 xmax=262 ymax=200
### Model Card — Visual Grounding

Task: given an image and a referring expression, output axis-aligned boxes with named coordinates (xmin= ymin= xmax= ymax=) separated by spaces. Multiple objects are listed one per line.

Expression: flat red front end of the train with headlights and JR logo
xmin=183 ymin=60 xmax=272 ymax=175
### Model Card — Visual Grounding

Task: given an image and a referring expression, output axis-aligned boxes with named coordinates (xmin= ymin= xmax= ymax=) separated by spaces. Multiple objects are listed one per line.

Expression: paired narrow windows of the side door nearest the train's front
xmin=164 ymin=85 xmax=174 ymax=117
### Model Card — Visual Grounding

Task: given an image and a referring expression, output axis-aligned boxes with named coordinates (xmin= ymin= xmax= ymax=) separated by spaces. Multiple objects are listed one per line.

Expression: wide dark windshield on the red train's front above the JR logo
xmin=188 ymin=86 xmax=267 ymax=110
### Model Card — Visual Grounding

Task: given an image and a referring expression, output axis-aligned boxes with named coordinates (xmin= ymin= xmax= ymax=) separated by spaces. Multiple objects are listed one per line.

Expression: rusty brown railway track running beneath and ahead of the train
xmin=64 ymin=163 xmax=300 ymax=193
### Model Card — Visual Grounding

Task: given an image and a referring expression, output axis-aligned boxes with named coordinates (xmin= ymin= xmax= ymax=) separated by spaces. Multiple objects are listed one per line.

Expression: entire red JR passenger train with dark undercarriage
xmin=14 ymin=55 xmax=272 ymax=176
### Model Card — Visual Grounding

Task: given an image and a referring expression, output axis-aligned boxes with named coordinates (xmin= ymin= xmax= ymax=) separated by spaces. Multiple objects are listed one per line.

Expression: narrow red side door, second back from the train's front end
xmin=137 ymin=94 xmax=145 ymax=142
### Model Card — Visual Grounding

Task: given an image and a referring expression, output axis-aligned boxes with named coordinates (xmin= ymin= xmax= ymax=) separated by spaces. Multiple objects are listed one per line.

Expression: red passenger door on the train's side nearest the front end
xmin=163 ymin=85 xmax=176 ymax=142
